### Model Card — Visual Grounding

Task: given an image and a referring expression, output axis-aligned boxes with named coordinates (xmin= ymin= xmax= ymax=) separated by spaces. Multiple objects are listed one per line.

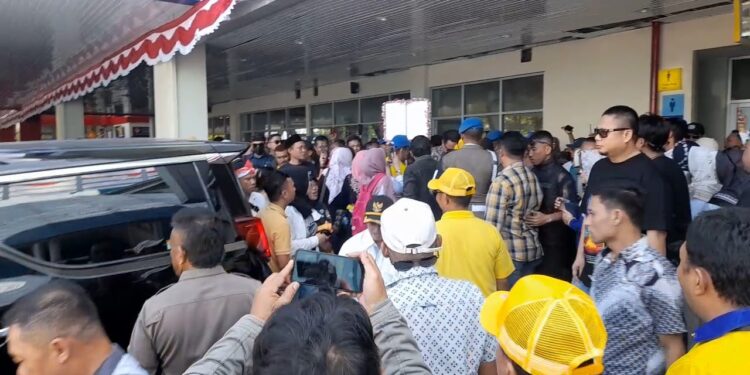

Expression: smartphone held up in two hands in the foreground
xmin=292 ymin=250 xmax=365 ymax=299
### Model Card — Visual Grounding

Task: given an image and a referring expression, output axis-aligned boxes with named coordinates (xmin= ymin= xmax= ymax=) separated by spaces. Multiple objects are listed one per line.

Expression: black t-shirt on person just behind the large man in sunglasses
xmin=652 ymin=155 xmax=692 ymax=262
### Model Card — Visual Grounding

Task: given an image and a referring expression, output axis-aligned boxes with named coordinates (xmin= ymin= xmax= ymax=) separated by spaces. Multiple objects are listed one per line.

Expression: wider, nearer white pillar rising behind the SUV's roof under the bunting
xmin=154 ymin=45 xmax=208 ymax=140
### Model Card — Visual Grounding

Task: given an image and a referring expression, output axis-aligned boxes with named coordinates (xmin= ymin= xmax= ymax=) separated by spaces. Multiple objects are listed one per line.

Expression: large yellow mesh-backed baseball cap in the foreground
xmin=479 ymin=275 xmax=607 ymax=375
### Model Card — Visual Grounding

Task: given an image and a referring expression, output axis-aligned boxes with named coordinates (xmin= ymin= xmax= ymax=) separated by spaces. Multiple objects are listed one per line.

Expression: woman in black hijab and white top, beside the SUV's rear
xmin=285 ymin=169 xmax=328 ymax=255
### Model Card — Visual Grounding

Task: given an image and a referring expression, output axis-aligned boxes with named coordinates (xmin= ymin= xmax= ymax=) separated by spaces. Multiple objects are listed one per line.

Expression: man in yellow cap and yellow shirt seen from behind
xmin=427 ymin=168 xmax=514 ymax=297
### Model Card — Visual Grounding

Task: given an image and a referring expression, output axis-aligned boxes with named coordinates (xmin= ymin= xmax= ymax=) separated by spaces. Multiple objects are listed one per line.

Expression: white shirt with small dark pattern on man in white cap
xmin=388 ymin=267 xmax=497 ymax=375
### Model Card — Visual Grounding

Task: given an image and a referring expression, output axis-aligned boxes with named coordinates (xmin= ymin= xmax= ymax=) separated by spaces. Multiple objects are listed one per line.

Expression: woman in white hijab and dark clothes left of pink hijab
xmin=323 ymin=147 xmax=357 ymax=252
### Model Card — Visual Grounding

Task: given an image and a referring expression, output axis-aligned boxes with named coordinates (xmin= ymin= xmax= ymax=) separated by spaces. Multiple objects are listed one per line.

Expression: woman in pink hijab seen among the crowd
xmin=352 ymin=148 xmax=396 ymax=234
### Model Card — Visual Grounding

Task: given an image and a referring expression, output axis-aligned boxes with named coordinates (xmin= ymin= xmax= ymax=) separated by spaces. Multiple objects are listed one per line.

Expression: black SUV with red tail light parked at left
xmin=0 ymin=139 xmax=268 ymax=374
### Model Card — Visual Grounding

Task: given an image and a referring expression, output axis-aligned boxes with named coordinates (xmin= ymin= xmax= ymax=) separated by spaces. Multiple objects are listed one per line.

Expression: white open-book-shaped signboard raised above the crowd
xmin=383 ymin=98 xmax=431 ymax=141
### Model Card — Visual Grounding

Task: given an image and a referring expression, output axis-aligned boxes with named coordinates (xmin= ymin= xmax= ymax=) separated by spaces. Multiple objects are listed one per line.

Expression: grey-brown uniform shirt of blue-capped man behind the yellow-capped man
xmin=442 ymin=143 xmax=495 ymax=206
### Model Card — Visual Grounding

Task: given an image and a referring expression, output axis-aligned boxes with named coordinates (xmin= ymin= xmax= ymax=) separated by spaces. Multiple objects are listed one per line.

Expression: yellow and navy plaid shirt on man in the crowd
xmin=486 ymin=162 xmax=543 ymax=262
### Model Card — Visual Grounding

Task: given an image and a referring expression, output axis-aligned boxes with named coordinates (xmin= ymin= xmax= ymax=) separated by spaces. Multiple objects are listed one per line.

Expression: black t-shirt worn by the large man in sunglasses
xmin=581 ymin=153 xmax=672 ymax=286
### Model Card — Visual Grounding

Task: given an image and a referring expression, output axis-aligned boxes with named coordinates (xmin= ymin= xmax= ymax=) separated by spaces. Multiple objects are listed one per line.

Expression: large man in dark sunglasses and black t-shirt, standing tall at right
xmin=573 ymin=105 xmax=671 ymax=294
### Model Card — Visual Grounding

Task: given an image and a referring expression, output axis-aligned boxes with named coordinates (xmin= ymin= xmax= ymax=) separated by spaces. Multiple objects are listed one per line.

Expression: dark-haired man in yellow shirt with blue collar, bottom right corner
xmin=667 ymin=208 xmax=750 ymax=375
